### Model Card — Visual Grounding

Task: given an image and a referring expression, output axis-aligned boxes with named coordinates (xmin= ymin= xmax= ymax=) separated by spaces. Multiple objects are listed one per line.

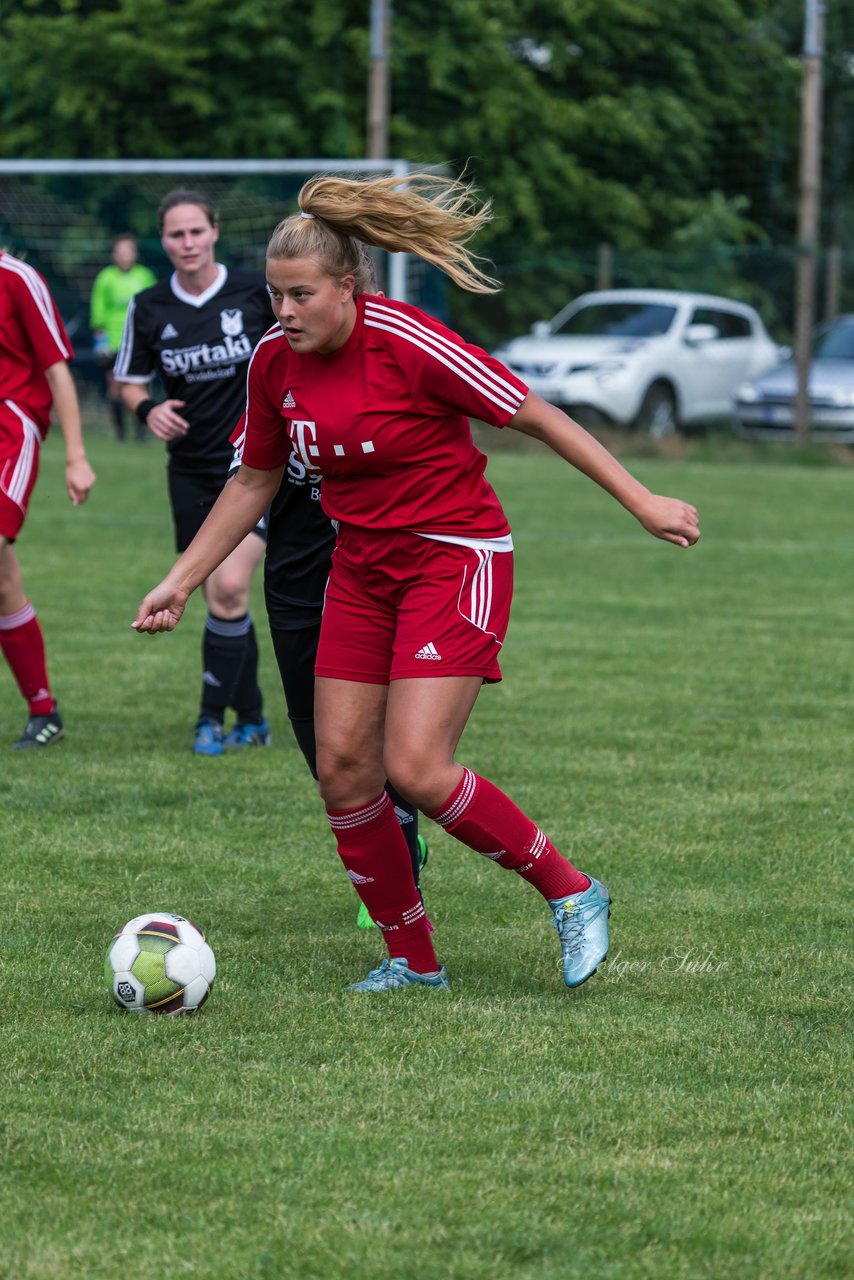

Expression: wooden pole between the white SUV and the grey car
xmin=795 ymin=0 xmax=825 ymax=440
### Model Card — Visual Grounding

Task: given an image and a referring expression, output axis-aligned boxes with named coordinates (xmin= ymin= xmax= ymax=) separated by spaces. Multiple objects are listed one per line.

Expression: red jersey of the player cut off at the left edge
xmin=0 ymin=253 xmax=74 ymax=435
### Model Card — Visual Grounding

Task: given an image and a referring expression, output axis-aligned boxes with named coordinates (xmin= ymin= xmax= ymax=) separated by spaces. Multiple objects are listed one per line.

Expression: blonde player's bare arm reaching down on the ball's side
xmin=132 ymin=466 xmax=284 ymax=634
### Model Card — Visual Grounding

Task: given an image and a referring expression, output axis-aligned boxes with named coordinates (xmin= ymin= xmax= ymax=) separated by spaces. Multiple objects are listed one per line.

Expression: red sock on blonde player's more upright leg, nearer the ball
xmin=326 ymin=791 xmax=439 ymax=973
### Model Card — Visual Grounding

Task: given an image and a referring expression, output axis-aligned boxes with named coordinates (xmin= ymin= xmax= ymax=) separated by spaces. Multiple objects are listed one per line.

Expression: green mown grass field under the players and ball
xmin=0 ymin=431 xmax=854 ymax=1280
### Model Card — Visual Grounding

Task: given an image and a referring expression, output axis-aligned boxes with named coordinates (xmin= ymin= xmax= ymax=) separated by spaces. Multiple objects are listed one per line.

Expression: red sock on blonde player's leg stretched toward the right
xmin=430 ymin=769 xmax=590 ymax=899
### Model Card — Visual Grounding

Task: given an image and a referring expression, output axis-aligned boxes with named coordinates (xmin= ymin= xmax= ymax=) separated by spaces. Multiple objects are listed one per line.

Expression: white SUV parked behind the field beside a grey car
xmin=495 ymin=289 xmax=780 ymax=436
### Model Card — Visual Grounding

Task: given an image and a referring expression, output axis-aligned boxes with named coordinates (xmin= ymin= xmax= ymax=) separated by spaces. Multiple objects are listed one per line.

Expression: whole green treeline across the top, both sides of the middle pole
xmin=0 ymin=0 xmax=809 ymax=340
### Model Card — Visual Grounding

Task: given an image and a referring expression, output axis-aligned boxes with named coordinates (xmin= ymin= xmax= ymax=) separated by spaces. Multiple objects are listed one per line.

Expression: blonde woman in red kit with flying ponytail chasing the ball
xmin=134 ymin=174 xmax=699 ymax=992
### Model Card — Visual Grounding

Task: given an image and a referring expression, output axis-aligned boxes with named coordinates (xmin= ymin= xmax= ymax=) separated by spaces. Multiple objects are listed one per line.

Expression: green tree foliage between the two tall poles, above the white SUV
xmin=392 ymin=0 xmax=798 ymax=332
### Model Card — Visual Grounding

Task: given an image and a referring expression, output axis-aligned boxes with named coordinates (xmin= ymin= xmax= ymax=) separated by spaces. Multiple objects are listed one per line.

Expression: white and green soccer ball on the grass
xmin=104 ymin=911 xmax=216 ymax=1014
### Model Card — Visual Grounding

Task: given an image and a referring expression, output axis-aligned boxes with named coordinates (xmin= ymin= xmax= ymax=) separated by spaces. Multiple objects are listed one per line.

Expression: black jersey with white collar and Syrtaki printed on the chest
xmin=114 ymin=266 xmax=271 ymax=475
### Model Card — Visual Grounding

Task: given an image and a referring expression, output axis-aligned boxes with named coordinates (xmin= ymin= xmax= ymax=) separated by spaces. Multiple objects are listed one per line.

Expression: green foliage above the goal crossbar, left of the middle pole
xmin=0 ymin=0 xmax=364 ymax=159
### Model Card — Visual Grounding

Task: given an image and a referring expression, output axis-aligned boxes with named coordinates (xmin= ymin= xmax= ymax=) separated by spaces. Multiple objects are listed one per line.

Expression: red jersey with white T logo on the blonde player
xmin=243 ymin=294 xmax=528 ymax=538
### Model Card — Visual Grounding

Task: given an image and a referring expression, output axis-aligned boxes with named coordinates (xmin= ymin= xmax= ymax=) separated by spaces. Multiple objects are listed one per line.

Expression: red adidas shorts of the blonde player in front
xmin=315 ymin=527 xmax=513 ymax=685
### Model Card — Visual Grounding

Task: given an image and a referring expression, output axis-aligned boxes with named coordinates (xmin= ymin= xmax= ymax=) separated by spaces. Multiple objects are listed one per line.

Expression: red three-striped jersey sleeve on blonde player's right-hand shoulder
xmin=365 ymin=297 xmax=528 ymax=426
